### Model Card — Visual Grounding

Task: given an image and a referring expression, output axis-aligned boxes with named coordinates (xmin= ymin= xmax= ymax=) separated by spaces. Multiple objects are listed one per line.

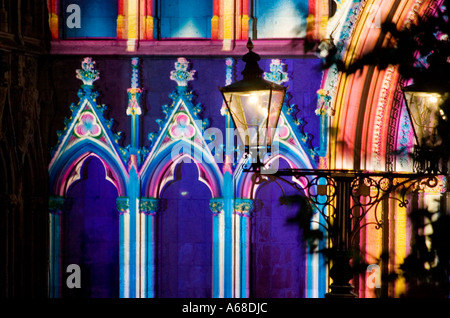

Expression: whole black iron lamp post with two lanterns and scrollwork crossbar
xmin=219 ymin=39 xmax=447 ymax=298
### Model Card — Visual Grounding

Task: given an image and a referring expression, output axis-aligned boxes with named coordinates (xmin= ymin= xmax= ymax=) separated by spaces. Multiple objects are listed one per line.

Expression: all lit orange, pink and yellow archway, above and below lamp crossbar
xmin=317 ymin=0 xmax=446 ymax=297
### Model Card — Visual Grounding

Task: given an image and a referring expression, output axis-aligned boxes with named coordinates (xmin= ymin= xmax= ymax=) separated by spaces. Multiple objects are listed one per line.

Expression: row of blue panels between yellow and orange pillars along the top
xmin=48 ymin=0 xmax=328 ymax=41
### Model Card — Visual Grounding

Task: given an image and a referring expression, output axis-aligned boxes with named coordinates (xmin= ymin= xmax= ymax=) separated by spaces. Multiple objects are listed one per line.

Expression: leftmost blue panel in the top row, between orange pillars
xmin=60 ymin=0 xmax=118 ymax=39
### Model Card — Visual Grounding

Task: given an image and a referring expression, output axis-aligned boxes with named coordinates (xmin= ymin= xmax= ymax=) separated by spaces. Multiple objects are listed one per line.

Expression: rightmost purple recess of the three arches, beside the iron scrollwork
xmin=250 ymin=159 xmax=306 ymax=298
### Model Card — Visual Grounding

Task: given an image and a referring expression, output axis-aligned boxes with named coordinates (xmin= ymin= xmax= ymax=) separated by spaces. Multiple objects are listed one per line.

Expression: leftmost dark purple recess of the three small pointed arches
xmin=62 ymin=157 xmax=119 ymax=298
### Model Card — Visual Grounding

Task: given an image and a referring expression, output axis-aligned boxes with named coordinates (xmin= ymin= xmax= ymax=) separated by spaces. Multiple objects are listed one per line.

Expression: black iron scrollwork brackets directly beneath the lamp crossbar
xmin=252 ymin=169 xmax=445 ymax=246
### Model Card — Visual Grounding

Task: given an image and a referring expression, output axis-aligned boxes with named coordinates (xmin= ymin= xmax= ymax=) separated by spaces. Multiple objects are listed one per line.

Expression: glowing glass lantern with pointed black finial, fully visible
xmin=219 ymin=38 xmax=286 ymax=172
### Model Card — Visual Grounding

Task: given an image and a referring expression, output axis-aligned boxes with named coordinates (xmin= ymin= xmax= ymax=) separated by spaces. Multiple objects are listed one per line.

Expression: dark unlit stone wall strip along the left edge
xmin=0 ymin=0 xmax=52 ymax=298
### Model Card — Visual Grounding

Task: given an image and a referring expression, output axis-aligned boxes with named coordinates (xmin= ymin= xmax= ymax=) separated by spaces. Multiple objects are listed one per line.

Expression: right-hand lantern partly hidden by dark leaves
xmin=403 ymin=82 xmax=449 ymax=173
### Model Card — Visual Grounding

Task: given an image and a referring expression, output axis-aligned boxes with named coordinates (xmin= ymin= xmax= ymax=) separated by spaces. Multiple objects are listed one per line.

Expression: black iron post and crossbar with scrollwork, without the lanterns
xmin=246 ymin=165 xmax=446 ymax=298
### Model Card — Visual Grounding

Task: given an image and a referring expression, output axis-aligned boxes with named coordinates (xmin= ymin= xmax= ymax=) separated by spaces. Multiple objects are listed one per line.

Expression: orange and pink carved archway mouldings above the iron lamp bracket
xmin=323 ymin=0 xmax=435 ymax=170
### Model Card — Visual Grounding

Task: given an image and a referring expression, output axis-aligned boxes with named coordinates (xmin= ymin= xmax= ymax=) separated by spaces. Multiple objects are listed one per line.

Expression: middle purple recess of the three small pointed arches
xmin=157 ymin=163 xmax=212 ymax=298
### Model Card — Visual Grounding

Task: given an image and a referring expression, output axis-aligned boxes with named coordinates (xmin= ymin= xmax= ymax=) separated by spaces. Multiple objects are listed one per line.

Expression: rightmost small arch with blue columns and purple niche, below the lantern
xmin=235 ymin=142 xmax=320 ymax=297
